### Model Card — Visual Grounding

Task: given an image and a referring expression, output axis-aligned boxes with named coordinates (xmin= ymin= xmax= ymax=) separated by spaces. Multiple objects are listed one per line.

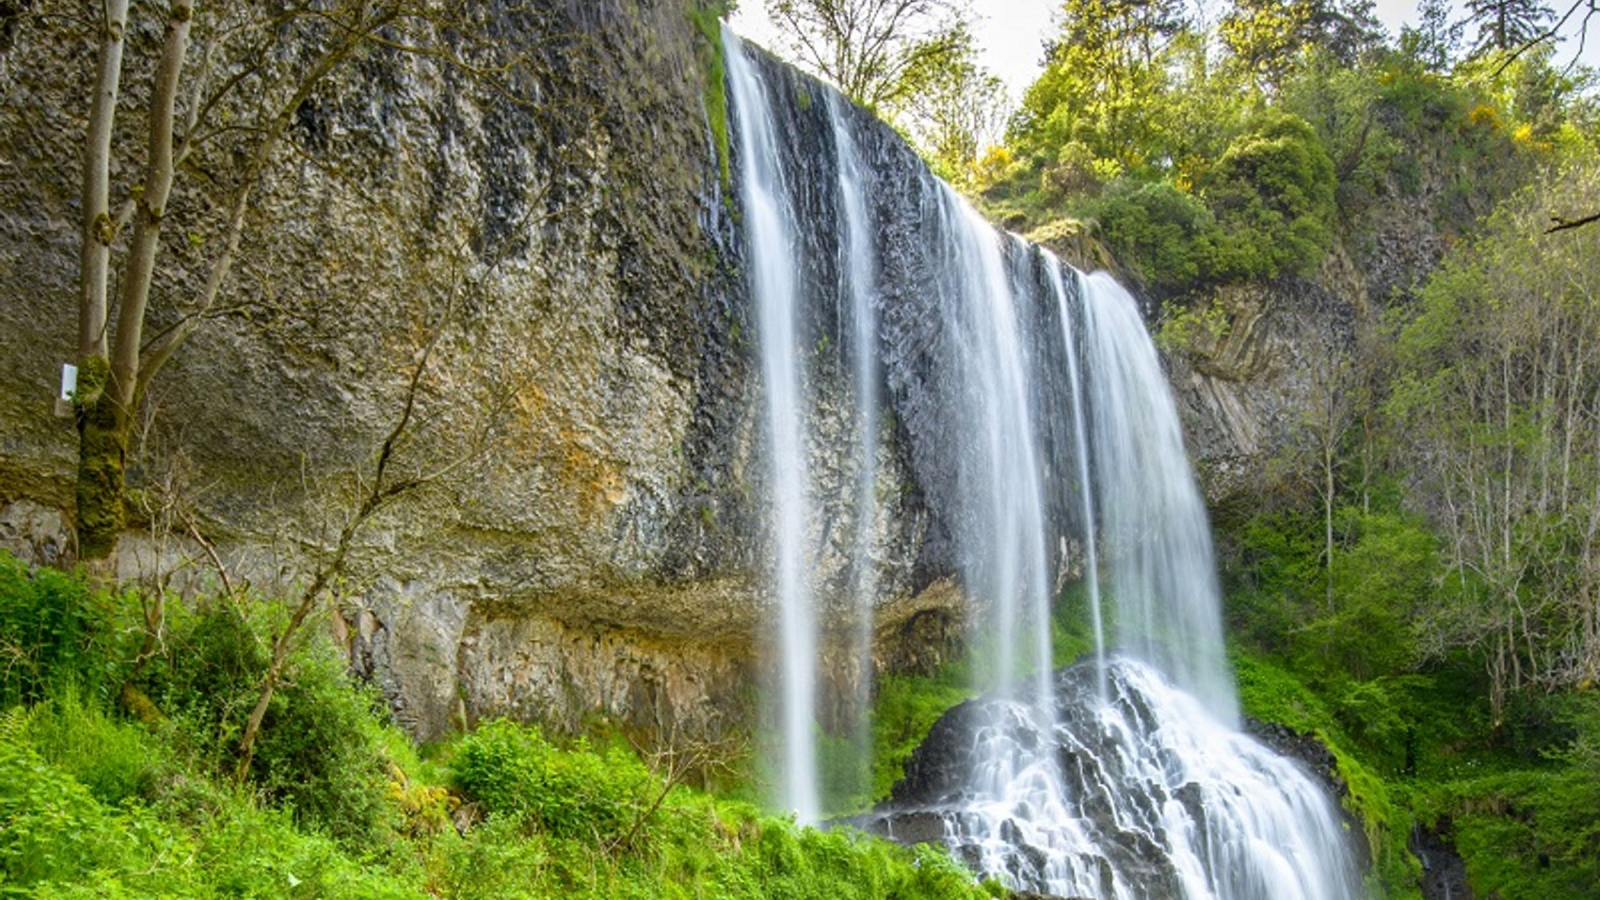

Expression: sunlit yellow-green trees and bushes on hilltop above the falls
xmin=965 ymin=0 xmax=1597 ymax=303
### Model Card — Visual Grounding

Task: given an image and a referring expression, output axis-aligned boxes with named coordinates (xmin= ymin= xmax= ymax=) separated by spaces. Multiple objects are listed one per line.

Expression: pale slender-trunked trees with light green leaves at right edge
xmin=1382 ymin=162 xmax=1600 ymax=717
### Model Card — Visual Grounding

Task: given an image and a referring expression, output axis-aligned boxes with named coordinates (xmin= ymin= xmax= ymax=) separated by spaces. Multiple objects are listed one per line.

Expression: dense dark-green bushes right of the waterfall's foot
xmin=1226 ymin=432 xmax=1600 ymax=900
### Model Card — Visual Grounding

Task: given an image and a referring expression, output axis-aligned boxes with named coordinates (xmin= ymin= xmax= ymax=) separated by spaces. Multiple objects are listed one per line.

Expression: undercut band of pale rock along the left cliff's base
xmin=0 ymin=501 xmax=970 ymax=748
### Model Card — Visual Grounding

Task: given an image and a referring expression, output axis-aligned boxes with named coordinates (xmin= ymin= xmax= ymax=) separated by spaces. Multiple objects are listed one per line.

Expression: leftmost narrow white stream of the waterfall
xmin=723 ymin=29 xmax=821 ymax=823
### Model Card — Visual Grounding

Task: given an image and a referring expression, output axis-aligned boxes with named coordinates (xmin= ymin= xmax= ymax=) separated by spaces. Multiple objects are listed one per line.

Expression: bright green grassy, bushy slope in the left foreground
xmin=0 ymin=552 xmax=995 ymax=900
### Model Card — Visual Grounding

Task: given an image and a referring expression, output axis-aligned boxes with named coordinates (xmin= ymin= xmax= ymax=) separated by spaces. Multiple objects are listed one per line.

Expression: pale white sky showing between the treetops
xmin=731 ymin=0 xmax=1600 ymax=101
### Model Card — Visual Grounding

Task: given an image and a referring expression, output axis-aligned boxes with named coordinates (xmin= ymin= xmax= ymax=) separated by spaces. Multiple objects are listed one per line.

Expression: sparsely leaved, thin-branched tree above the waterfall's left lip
xmin=766 ymin=0 xmax=971 ymax=107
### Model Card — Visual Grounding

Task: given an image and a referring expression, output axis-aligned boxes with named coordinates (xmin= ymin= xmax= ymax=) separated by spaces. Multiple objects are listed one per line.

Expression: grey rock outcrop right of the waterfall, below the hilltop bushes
xmin=1147 ymin=147 xmax=1459 ymax=516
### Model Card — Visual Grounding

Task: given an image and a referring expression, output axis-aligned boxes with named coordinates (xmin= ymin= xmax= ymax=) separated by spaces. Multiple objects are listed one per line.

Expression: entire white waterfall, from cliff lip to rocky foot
xmin=725 ymin=32 xmax=1360 ymax=900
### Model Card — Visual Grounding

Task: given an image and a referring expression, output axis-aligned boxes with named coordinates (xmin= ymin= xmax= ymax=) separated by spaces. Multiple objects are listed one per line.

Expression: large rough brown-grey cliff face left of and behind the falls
xmin=0 ymin=0 xmax=985 ymax=740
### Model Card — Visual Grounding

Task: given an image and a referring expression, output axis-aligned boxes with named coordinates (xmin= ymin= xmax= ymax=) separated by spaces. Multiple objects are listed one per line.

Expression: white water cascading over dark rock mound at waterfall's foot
xmin=862 ymin=658 xmax=1360 ymax=900
